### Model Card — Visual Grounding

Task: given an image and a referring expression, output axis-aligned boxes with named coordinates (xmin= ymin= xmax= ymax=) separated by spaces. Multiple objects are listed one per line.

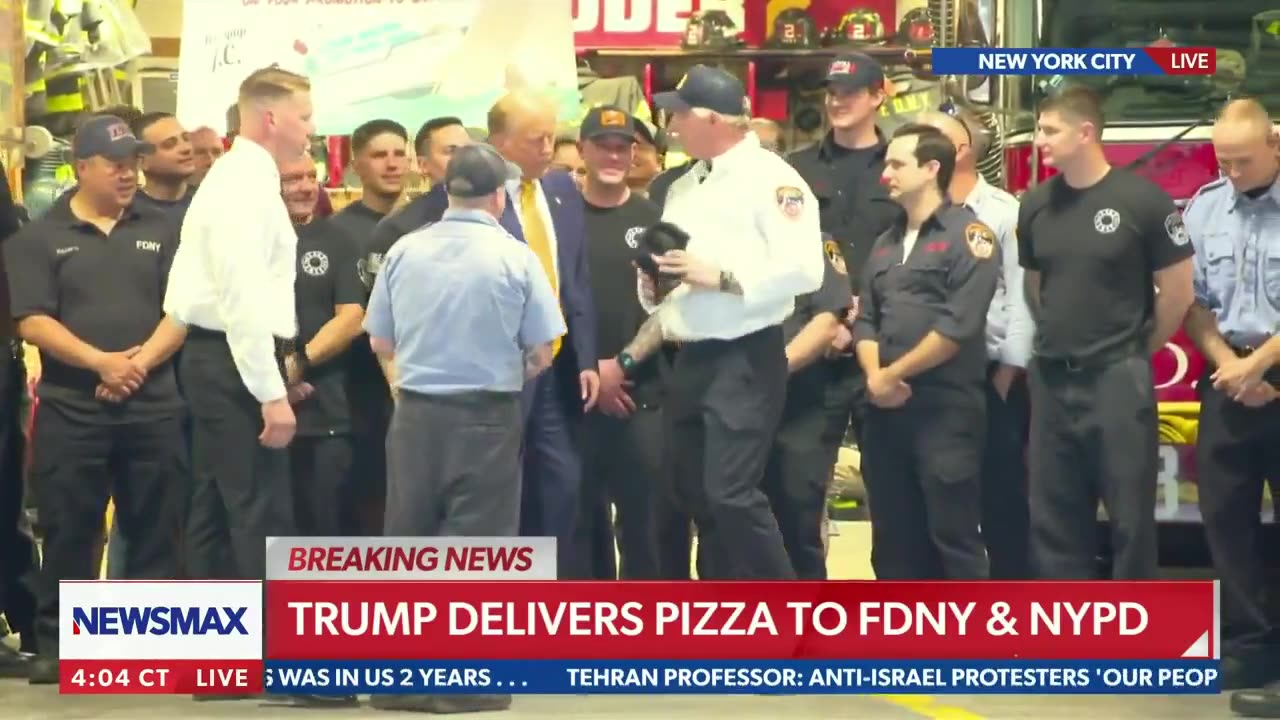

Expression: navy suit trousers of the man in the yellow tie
xmin=520 ymin=366 xmax=582 ymax=577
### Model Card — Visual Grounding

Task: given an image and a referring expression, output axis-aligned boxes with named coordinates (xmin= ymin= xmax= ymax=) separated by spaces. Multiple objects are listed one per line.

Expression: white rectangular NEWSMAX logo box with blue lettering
xmin=58 ymin=580 xmax=262 ymax=660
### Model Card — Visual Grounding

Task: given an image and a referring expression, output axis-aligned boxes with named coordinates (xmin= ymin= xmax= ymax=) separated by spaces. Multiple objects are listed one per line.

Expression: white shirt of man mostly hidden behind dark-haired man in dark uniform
xmin=964 ymin=176 xmax=1036 ymax=368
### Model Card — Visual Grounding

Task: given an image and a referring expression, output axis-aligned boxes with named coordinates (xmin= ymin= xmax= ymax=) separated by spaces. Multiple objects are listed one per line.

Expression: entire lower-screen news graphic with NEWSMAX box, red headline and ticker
xmin=61 ymin=538 xmax=1220 ymax=696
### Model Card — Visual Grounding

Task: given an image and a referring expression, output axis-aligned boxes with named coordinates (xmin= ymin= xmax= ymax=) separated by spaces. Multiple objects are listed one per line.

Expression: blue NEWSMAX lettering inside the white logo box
xmin=72 ymin=605 xmax=248 ymax=635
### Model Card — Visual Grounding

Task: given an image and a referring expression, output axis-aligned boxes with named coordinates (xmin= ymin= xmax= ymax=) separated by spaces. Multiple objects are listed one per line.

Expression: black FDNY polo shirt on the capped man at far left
xmin=4 ymin=196 xmax=183 ymax=424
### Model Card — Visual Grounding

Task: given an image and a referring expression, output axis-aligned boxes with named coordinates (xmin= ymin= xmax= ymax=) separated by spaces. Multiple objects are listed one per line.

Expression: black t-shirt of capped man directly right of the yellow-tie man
xmin=584 ymin=195 xmax=662 ymax=402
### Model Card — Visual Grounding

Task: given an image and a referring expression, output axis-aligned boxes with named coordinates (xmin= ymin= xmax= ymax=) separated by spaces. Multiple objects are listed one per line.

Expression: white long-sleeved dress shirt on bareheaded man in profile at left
xmin=164 ymin=136 xmax=298 ymax=402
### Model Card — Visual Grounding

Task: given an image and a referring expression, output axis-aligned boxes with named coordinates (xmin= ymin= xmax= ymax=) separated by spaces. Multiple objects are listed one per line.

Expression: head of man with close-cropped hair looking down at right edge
xmin=1213 ymin=100 xmax=1280 ymax=192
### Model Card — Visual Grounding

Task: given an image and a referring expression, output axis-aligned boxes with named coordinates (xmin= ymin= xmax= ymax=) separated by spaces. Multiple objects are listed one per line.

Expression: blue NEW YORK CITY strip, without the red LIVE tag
xmin=929 ymin=47 xmax=1165 ymax=76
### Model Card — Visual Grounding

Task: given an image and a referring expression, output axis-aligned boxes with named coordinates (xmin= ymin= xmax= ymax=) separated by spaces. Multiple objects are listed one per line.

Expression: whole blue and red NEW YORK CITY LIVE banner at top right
xmin=931 ymin=46 xmax=1217 ymax=76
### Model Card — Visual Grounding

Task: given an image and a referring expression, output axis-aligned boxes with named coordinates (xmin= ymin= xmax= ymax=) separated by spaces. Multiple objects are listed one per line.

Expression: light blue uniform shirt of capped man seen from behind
xmin=365 ymin=210 xmax=566 ymax=395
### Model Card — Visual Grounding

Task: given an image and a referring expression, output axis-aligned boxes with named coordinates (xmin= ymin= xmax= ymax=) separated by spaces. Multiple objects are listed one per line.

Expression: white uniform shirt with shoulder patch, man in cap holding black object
xmin=641 ymin=133 xmax=826 ymax=341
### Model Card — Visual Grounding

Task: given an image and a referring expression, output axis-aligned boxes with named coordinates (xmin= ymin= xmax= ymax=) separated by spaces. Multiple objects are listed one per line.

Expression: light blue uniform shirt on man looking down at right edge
xmin=1183 ymin=178 xmax=1280 ymax=347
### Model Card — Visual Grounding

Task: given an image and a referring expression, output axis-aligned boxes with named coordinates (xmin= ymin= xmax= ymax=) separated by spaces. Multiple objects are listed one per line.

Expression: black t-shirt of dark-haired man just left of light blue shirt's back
xmin=329 ymin=202 xmax=392 ymax=433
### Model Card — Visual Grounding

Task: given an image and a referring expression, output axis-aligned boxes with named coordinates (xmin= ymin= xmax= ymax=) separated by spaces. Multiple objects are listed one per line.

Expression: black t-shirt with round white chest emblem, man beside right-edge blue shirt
xmin=1018 ymin=168 xmax=1193 ymax=359
